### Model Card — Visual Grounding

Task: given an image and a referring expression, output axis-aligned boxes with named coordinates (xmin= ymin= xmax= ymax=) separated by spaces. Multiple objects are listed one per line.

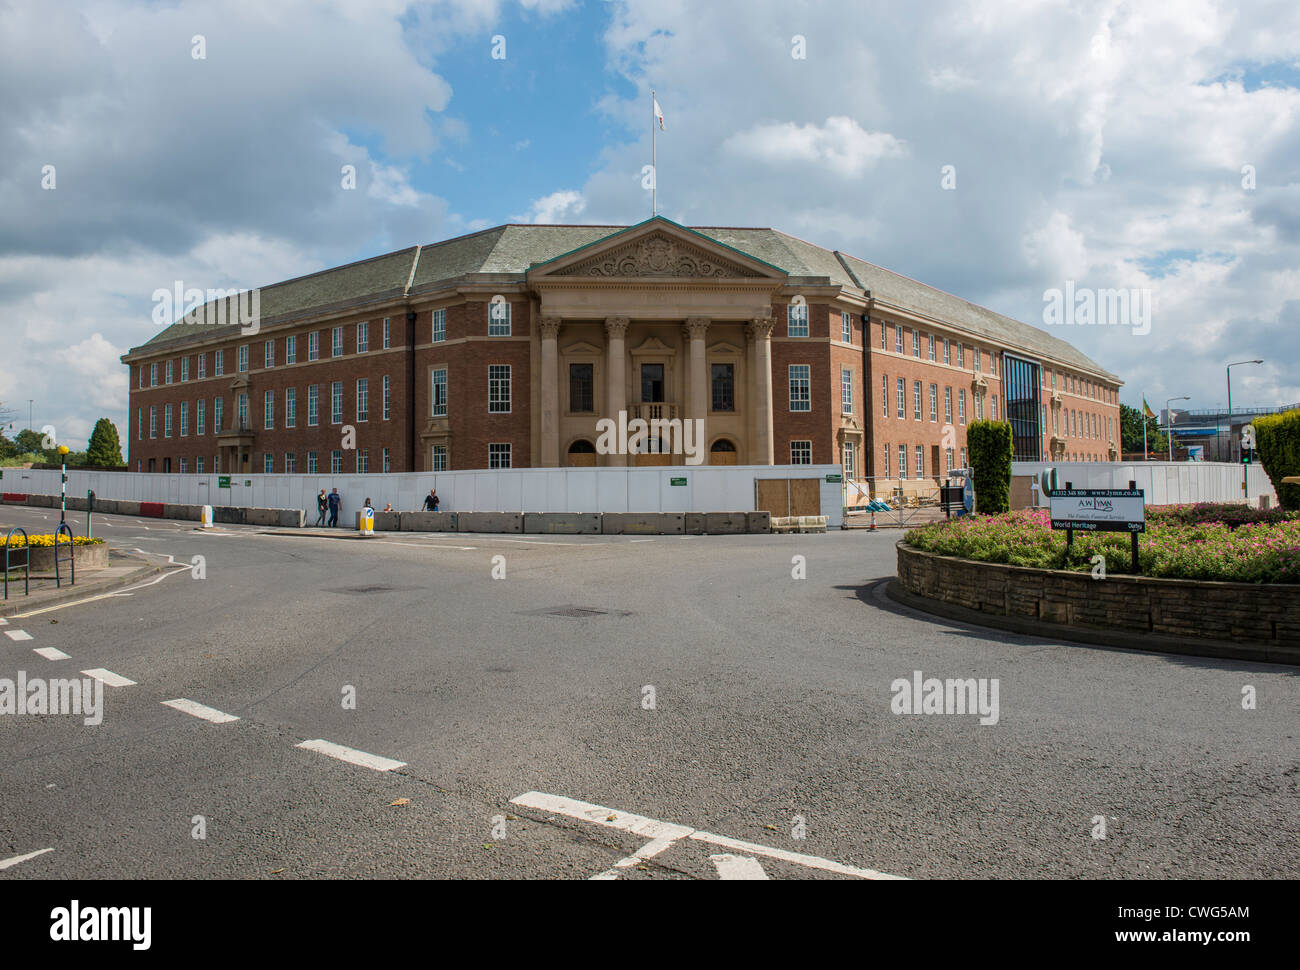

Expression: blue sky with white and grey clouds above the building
xmin=0 ymin=0 xmax=1300 ymax=446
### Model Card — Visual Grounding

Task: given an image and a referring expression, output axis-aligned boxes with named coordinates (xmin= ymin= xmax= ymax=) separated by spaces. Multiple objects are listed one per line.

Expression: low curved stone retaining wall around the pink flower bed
xmin=897 ymin=542 xmax=1300 ymax=648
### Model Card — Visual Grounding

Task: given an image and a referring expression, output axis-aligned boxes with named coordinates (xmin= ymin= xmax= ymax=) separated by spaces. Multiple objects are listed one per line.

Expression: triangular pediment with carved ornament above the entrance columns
xmin=529 ymin=217 xmax=785 ymax=282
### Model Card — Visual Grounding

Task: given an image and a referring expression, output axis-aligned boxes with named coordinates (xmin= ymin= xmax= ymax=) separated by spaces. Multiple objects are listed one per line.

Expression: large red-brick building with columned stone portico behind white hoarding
xmin=122 ymin=217 xmax=1121 ymax=488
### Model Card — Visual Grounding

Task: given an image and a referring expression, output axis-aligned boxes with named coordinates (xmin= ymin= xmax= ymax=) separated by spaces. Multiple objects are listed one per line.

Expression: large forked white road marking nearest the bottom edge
xmin=510 ymin=792 xmax=906 ymax=879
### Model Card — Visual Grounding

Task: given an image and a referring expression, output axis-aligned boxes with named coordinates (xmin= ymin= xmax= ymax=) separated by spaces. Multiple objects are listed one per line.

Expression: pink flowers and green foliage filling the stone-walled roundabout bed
xmin=904 ymin=505 xmax=1300 ymax=583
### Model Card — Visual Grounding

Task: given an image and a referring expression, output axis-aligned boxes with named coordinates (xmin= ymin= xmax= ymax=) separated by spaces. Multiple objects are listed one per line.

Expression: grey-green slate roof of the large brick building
xmin=133 ymin=217 xmax=1119 ymax=381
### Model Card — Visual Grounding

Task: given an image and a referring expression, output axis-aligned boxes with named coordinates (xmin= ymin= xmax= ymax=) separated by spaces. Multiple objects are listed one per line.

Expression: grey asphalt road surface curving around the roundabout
xmin=0 ymin=507 xmax=1300 ymax=879
